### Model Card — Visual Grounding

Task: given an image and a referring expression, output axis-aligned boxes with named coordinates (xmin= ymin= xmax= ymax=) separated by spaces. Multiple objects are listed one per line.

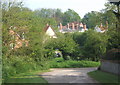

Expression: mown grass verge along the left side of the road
xmin=2 ymin=70 xmax=49 ymax=85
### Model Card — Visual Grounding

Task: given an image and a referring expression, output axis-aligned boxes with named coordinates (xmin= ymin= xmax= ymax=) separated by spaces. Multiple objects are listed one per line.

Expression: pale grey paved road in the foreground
xmin=41 ymin=68 xmax=98 ymax=84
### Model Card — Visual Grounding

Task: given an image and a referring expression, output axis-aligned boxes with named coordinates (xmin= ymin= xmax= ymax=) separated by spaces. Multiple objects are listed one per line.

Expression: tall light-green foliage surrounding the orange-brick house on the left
xmin=2 ymin=2 xmax=55 ymax=78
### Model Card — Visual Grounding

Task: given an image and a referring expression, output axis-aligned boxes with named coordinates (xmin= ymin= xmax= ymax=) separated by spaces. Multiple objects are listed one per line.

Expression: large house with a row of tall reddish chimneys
xmin=59 ymin=22 xmax=88 ymax=33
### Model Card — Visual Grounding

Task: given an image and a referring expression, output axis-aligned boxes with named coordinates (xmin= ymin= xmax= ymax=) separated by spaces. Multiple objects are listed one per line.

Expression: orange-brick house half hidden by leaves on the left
xmin=9 ymin=26 xmax=28 ymax=49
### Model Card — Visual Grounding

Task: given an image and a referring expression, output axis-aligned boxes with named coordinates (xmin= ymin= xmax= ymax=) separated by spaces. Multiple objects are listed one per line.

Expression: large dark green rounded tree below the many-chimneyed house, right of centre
xmin=73 ymin=30 xmax=108 ymax=61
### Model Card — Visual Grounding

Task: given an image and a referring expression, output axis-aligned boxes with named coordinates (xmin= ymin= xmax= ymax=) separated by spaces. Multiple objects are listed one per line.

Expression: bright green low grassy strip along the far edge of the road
xmin=49 ymin=58 xmax=100 ymax=68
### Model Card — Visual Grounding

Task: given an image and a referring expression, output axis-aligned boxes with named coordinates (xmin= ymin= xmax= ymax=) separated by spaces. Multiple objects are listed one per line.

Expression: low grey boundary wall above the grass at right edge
xmin=100 ymin=60 xmax=120 ymax=75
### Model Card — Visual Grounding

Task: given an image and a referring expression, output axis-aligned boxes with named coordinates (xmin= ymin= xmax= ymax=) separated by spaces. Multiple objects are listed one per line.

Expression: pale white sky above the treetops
xmin=23 ymin=0 xmax=107 ymax=18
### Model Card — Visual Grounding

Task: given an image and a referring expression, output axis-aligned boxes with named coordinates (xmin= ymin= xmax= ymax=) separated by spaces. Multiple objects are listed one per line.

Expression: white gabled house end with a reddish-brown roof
xmin=44 ymin=25 xmax=57 ymax=38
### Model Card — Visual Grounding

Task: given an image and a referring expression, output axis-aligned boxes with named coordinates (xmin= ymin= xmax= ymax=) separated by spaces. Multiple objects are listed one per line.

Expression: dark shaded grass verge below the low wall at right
xmin=88 ymin=70 xmax=120 ymax=85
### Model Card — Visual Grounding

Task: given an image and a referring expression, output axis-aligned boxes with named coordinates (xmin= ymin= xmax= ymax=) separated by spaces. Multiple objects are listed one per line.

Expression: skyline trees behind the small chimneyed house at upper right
xmin=82 ymin=3 xmax=118 ymax=28
